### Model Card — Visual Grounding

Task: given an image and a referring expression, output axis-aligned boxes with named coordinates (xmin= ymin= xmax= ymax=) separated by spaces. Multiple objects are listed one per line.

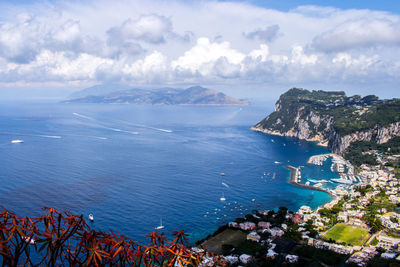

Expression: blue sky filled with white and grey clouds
xmin=0 ymin=0 xmax=400 ymax=98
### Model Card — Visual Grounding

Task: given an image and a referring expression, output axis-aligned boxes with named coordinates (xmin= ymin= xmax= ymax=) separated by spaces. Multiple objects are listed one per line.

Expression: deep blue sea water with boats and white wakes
xmin=0 ymin=103 xmax=337 ymax=245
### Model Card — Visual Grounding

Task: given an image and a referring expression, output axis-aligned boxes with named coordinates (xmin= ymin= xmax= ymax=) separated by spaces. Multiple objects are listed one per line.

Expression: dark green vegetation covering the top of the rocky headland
xmin=259 ymin=88 xmax=400 ymax=135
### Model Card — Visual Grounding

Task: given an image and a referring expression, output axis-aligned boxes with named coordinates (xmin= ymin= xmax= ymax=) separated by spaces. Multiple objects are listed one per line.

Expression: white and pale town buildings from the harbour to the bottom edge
xmin=198 ymin=154 xmax=400 ymax=266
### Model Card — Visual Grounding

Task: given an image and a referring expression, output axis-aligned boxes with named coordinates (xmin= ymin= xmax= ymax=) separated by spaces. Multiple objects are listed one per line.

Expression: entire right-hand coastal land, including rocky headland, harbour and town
xmin=197 ymin=89 xmax=400 ymax=266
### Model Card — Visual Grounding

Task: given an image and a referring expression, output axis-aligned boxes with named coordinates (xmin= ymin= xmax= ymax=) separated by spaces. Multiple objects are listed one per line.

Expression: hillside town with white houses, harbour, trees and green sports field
xmin=196 ymin=154 xmax=400 ymax=266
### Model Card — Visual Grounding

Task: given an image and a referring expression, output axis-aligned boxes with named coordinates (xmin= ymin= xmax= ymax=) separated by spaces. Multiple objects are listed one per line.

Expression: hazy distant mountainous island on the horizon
xmin=63 ymin=85 xmax=249 ymax=106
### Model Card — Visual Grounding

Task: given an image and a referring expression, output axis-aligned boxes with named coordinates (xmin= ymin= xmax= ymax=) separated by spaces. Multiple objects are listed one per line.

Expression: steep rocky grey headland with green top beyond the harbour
xmin=252 ymin=88 xmax=400 ymax=154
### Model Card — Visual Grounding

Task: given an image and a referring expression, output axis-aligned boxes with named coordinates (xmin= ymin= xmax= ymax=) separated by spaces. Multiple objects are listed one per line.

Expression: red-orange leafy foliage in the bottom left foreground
xmin=0 ymin=207 xmax=226 ymax=266
